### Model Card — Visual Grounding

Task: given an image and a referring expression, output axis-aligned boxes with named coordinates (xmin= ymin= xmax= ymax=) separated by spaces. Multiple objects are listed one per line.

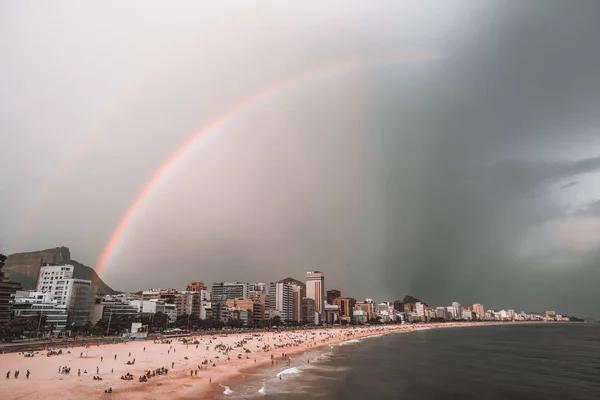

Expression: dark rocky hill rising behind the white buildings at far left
xmin=4 ymin=247 xmax=117 ymax=294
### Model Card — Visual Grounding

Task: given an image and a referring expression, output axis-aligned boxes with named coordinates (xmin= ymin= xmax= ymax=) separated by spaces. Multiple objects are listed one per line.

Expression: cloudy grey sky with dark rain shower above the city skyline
xmin=0 ymin=1 xmax=600 ymax=316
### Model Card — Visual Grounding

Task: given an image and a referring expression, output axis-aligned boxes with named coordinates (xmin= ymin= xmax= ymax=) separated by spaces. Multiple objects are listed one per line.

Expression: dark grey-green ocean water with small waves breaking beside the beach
xmin=210 ymin=323 xmax=600 ymax=400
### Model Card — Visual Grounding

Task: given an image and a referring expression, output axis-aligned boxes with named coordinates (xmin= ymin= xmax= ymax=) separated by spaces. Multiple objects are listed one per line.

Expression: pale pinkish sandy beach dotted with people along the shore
xmin=0 ymin=322 xmax=524 ymax=400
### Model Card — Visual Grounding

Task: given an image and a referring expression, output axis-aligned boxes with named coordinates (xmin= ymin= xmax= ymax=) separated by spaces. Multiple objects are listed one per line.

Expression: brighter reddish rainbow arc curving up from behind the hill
xmin=95 ymin=53 xmax=431 ymax=275
